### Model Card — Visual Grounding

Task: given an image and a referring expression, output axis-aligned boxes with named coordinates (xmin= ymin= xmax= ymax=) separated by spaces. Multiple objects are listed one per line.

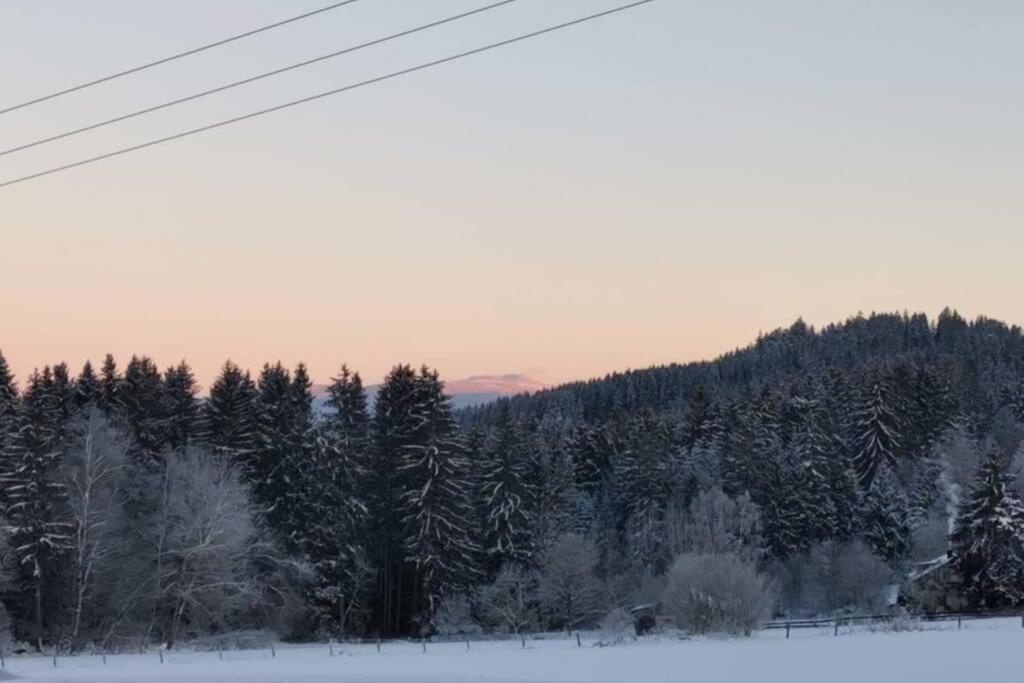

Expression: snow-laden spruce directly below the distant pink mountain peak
xmin=478 ymin=402 xmax=536 ymax=575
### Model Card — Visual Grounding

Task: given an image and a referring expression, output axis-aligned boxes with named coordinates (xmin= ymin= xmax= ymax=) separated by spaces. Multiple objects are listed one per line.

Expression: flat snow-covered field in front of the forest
xmin=7 ymin=620 xmax=1024 ymax=683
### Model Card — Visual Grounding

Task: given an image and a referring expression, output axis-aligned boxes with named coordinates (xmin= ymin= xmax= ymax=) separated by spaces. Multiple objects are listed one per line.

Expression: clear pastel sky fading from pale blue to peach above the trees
xmin=0 ymin=0 xmax=1024 ymax=386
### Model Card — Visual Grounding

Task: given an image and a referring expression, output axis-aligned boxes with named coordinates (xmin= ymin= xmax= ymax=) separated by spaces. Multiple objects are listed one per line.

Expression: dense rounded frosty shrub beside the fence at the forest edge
xmin=662 ymin=553 xmax=775 ymax=636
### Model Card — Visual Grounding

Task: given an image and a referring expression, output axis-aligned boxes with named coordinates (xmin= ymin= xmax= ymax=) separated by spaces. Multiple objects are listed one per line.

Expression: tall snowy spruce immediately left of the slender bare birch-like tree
xmin=0 ymin=368 xmax=68 ymax=649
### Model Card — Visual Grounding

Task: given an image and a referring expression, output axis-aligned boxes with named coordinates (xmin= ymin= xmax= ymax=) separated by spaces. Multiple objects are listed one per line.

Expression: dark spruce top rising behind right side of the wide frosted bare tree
xmin=200 ymin=360 xmax=256 ymax=470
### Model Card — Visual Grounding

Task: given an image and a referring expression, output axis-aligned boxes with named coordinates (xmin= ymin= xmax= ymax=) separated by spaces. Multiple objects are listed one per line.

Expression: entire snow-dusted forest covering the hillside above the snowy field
xmin=0 ymin=309 xmax=1024 ymax=651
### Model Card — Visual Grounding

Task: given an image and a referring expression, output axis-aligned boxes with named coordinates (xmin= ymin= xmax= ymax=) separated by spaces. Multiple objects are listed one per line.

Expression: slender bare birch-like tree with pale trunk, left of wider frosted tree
xmin=61 ymin=409 xmax=126 ymax=646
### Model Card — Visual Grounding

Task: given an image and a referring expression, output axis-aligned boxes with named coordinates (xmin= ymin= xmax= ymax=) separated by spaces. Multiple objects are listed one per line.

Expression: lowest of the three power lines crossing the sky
xmin=0 ymin=0 xmax=654 ymax=187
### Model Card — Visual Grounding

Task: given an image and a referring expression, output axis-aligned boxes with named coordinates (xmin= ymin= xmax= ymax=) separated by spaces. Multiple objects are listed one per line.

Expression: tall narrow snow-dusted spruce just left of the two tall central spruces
xmin=313 ymin=366 xmax=370 ymax=633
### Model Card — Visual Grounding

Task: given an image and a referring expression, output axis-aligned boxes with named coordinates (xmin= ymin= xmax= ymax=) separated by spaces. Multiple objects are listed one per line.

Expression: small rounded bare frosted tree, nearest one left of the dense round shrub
xmin=538 ymin=533 xmax=603 ymax=630
